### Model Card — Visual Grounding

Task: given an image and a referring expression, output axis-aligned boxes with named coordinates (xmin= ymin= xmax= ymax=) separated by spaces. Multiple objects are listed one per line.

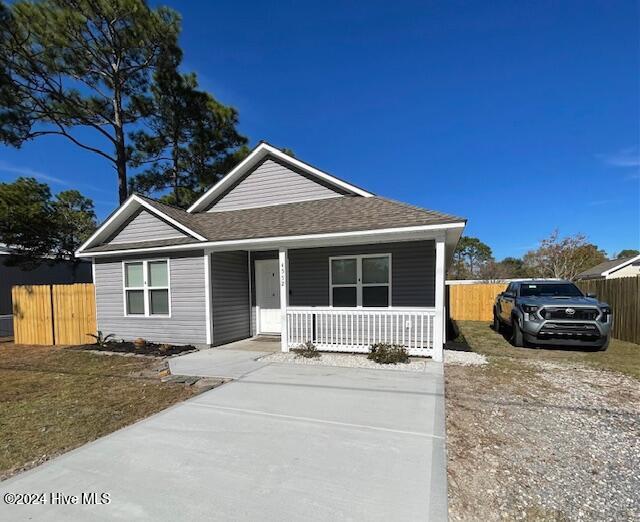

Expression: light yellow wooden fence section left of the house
xmin=11 ymin=283 xmax=96 ymax=344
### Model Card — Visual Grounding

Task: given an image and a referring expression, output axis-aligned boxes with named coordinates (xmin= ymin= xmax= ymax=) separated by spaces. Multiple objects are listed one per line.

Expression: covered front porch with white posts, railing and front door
xmin=205 ymin=233 xmax=447 ymax=361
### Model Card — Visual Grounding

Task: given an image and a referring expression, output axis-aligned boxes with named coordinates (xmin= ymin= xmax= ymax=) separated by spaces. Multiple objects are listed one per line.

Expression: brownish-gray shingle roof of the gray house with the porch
xmin=84 ymin=196 xmax=466 ymax=254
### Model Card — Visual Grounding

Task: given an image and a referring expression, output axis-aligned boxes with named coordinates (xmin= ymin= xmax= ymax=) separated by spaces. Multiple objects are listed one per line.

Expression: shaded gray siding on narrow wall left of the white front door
xmin=211 ymin=251 xmax=251 ymax=346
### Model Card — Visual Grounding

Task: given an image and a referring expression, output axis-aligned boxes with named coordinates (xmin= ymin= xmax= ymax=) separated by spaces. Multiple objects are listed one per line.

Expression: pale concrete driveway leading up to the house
xmin=0 ymin=354 xmax=447 ymax=521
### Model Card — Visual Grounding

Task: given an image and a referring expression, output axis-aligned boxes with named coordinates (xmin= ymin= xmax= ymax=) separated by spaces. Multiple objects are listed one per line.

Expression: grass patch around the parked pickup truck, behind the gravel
xmin=458 ymin=321 xmax=640 ymax=379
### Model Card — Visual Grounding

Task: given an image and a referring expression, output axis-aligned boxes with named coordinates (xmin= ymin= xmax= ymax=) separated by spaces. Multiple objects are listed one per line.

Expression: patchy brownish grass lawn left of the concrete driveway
xmin=0 ymin=343 xmax=194 ymax=479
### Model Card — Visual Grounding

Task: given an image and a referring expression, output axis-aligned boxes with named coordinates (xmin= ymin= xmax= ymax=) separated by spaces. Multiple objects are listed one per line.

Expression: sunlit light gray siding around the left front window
xmin=95 ymin=251 xmax=206 ymax=345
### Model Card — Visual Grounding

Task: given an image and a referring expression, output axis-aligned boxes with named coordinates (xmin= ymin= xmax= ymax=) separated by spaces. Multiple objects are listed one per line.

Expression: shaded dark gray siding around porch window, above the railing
xmin=289 ymin=241 xmax=435 ymax=307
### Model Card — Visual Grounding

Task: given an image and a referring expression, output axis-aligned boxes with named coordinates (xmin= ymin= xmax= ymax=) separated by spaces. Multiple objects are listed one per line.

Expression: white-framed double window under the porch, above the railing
xmin=329 ymin=254 xmax=391 ymax=307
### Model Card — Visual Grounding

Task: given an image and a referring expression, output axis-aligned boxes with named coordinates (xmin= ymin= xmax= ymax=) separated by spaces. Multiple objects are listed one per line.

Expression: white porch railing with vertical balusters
xmin=287 ymin=306 xmax=436 ymax=356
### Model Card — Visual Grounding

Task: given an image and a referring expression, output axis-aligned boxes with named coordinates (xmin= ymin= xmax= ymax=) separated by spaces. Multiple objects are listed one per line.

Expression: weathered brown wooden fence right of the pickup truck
xmin=578 ymin=276 xmax=640 ymax=344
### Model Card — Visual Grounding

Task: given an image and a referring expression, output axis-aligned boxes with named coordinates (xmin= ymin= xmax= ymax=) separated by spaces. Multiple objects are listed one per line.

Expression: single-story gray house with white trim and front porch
xmin=77 ymin=142 xmax=466 ymax=360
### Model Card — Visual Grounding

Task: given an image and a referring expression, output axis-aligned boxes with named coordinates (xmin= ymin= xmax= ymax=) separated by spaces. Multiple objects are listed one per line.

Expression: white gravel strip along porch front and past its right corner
xmin=260 ymin=350 xmax=487 ymax=372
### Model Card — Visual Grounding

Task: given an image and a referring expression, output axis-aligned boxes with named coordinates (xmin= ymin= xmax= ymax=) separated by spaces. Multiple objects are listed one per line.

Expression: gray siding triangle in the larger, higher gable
xmin=208 ymin=159 xmax=343 ymax=212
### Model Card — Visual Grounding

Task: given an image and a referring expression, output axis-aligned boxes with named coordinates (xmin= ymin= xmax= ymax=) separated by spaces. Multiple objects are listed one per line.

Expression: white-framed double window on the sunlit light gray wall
xmin=123 ymin=259 xmax=171 ymax=317
